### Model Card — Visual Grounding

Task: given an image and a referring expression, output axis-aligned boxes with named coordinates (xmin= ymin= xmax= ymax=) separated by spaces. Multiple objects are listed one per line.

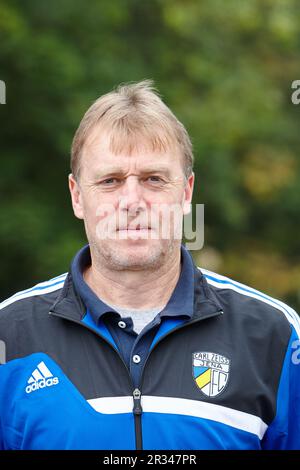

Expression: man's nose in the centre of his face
xmin=119 ymin=176 xmax=145 ymax=214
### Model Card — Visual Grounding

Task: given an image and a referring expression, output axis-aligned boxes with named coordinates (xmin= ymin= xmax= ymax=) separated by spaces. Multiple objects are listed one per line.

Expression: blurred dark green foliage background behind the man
xmin=0 ymin=0 xmax=300 ymax=310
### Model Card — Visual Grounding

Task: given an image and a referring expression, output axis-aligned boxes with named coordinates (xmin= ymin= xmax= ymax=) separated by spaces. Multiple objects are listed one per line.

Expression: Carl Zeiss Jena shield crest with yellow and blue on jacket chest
xmin=193 ymin=352 xmax=230 ymax=397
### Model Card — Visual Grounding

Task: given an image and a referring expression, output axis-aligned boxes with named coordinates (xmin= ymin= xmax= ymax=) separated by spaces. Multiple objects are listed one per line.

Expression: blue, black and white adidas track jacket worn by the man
xmin=0 ymin=260 xmax=300 ymax=450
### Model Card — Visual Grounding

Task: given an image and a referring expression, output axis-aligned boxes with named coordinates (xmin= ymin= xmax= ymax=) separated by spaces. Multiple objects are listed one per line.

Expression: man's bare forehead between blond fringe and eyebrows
xmin=81 ymin=128 xmax=182 ymax=172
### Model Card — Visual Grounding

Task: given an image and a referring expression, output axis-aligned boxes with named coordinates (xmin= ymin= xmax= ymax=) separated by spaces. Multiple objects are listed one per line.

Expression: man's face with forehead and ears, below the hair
xmin=69 ymin=129 xmax=194 ymax=270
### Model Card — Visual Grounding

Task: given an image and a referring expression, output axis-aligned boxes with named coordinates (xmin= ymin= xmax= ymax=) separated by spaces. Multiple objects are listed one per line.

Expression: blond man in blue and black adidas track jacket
xmin=0 ymin=81 xmax=300 ymax=449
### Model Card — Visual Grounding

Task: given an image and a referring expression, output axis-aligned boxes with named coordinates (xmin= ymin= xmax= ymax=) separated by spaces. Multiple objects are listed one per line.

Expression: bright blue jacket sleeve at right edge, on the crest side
xmin=262 ymin=324 xmax=300 ymax=450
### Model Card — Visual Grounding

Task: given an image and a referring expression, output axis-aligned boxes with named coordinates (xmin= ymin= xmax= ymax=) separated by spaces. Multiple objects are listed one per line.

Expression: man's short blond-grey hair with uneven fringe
xmin=71 ymin=80 xmax=193 ymax=178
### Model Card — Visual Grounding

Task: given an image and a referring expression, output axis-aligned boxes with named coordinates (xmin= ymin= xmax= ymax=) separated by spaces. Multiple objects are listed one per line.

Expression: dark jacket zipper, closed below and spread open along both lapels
xmin=49 ymin=310 xmax=223 ymax=450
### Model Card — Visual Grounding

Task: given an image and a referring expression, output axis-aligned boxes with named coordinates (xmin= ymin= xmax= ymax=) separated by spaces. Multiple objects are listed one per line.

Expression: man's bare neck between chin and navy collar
xmin=83 ymin=247 xmax=180 ymax=309
